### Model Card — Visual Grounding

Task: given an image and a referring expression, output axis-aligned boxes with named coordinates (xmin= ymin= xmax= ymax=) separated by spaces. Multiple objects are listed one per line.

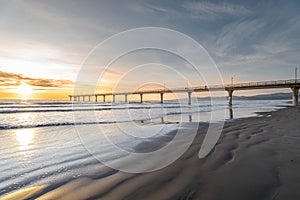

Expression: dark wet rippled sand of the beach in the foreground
xmin=1 ymin=107 xmax=300 ymax=200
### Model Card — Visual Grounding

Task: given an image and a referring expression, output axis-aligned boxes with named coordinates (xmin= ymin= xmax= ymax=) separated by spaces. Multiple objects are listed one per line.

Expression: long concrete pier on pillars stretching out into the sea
xmin=69 ymin=79 xmax=300 ymax=106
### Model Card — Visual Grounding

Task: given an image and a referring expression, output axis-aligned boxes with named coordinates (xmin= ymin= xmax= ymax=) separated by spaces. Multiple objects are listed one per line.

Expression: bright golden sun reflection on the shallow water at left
xmin=16 ymin=129 xmax=34 ymax=151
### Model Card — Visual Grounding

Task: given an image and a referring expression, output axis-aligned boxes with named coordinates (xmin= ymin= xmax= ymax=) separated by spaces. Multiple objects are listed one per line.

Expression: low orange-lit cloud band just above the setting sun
xmin=0 ymin=71 xmax=74 ymax=88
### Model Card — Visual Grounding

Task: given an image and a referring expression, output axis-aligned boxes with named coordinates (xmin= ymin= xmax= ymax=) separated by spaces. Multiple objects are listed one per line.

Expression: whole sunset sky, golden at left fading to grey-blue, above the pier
xmin=0 ymin=0 xmax=300 ymax=99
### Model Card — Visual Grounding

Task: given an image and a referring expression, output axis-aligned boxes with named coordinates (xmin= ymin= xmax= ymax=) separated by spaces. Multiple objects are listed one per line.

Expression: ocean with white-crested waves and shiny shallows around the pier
xmin=0 ymin=100 xmax=289 ymax=196
